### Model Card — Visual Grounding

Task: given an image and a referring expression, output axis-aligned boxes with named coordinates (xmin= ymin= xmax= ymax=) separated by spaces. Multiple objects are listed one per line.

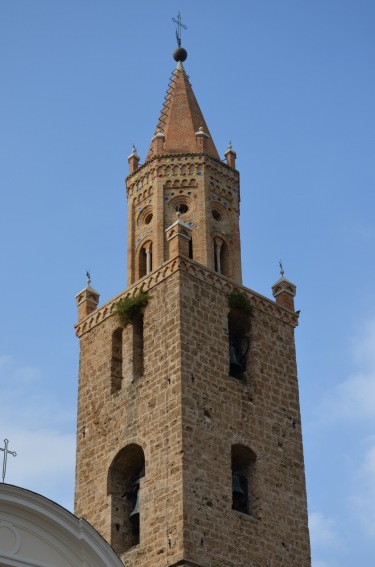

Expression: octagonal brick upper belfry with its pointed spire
xmin=126 ymin=47 xmax=242 ymax=285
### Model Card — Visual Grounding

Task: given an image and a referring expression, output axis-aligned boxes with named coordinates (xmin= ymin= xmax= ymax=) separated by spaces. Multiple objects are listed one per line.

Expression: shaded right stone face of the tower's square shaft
xmin=181 ymin=275 xmax=311 ymax=567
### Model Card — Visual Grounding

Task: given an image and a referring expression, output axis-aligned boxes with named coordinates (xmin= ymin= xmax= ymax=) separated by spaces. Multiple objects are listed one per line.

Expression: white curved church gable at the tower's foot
xmin=0 ymin=484 xmax=124 ymax=567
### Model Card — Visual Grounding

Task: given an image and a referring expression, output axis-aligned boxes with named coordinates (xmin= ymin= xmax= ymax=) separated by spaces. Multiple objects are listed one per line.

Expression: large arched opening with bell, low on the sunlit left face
xmin=108 ymin=443 xmax=145 ymax=554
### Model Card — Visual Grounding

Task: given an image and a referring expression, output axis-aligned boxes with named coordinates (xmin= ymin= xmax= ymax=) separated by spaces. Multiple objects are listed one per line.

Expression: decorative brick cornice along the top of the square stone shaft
xmin=75 ymin=256 xmax=298 ymax=337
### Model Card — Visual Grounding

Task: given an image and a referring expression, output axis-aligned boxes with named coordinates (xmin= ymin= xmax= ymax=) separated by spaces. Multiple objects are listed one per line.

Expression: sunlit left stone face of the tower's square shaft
xmin=75 ymin=273 xmax=187 ymax=567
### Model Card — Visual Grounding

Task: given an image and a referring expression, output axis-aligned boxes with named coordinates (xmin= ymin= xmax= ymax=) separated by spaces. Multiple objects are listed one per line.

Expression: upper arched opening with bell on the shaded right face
xmin=228 ymin=309 xmax=250 ymax=380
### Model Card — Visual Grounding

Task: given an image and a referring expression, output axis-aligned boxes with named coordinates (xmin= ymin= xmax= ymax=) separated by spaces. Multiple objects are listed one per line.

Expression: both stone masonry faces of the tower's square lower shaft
xmin=75 ymin=258 xmax=311 ymax=567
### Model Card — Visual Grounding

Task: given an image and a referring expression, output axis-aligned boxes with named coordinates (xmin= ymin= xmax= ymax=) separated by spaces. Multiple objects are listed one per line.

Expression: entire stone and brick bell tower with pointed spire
xmin=75 ymin=27 xmax=311 ymax=567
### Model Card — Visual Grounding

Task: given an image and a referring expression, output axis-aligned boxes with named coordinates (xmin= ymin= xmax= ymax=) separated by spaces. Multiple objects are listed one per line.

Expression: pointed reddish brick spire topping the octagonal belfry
xmin=146 ymin=60 xmax=220 ymax=161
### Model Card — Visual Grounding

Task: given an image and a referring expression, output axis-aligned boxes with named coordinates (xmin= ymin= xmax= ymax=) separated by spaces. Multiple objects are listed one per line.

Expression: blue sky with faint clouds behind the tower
xmin=0 ymin=0 xmax=375 ymax=567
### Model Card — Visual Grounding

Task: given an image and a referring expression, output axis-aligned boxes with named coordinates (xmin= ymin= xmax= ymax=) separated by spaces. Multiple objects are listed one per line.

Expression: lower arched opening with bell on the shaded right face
xmin=231 ymin=445 xmax=256 ymax=516
